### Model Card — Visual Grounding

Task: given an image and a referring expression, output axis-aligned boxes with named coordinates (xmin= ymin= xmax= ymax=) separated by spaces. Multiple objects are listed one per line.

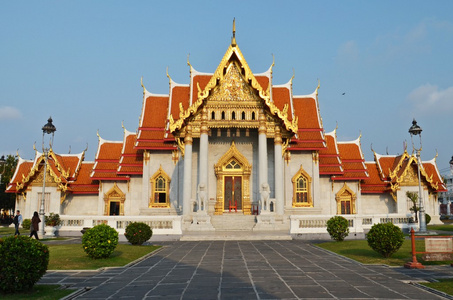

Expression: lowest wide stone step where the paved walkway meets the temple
xmin=180 ymin=231 xmax=292 ymax=242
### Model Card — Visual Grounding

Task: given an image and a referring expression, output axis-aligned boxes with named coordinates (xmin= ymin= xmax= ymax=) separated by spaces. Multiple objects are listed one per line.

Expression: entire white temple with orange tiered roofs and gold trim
xmin=7 ymin=28 xmax=445 ymax=237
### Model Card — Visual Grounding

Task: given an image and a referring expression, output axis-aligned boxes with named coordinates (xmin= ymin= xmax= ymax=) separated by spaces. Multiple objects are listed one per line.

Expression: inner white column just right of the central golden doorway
xmin=258 ymin=110 xmax=270 ymax=212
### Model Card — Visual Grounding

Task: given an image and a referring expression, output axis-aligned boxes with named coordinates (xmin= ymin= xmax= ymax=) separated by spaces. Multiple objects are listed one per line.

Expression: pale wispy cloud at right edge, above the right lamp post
xmin=407 ymin=83 xmax=453 ymax=115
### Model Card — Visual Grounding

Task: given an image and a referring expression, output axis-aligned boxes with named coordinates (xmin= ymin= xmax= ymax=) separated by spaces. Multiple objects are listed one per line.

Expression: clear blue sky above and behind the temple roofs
xmin=0 ymin=1 xmax=453 ymax=170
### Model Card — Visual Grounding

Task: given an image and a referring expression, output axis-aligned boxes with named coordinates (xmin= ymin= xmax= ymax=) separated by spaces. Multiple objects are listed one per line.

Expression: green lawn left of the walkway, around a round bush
xmin=47 ymin=244 xmax=160 ymax=270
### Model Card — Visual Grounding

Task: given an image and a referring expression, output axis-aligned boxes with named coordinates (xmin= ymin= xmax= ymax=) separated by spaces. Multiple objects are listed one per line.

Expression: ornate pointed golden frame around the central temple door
xmin=214 ymin=141 xmax=252 ymax=215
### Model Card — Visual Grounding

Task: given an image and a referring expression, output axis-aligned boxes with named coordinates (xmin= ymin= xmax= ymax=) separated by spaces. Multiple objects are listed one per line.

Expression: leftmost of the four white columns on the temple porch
xmin=182 ymin=124 xmax=193 ymax=216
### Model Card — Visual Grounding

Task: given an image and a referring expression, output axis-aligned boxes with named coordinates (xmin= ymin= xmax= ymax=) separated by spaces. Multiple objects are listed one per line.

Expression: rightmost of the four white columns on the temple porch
xmin=274 ymin=126 xmax=284 ymax=215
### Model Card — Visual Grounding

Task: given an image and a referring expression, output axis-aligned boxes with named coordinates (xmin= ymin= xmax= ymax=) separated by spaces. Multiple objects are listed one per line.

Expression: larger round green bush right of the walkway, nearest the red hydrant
xmin=367 ymin=222 xmax=404 ymax=257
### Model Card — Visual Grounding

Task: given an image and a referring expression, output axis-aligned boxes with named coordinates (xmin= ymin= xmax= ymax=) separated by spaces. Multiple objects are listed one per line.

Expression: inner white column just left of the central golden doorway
xmin=198 ymin=107 xmax=209 ymax=213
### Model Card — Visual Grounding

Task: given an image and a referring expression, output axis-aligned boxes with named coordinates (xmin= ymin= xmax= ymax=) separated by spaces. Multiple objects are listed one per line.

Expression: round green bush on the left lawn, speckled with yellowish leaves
xmin=82 ymin=224 xmax=118 ymax=258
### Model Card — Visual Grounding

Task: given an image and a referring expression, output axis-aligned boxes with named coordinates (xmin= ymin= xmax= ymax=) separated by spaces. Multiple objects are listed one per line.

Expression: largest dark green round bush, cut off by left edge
xmin=0 ymin=235 xmax=49 ymax=293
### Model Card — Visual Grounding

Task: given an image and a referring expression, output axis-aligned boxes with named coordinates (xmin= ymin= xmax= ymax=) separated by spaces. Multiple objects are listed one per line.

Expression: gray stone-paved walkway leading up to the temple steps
xmin=39 ymin=240 xmax=453 ymax=299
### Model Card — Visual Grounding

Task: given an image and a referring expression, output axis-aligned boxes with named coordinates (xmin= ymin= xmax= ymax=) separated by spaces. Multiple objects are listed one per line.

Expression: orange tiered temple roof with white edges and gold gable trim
xmin=7 ymin=28 xmax=445 ymax=199
